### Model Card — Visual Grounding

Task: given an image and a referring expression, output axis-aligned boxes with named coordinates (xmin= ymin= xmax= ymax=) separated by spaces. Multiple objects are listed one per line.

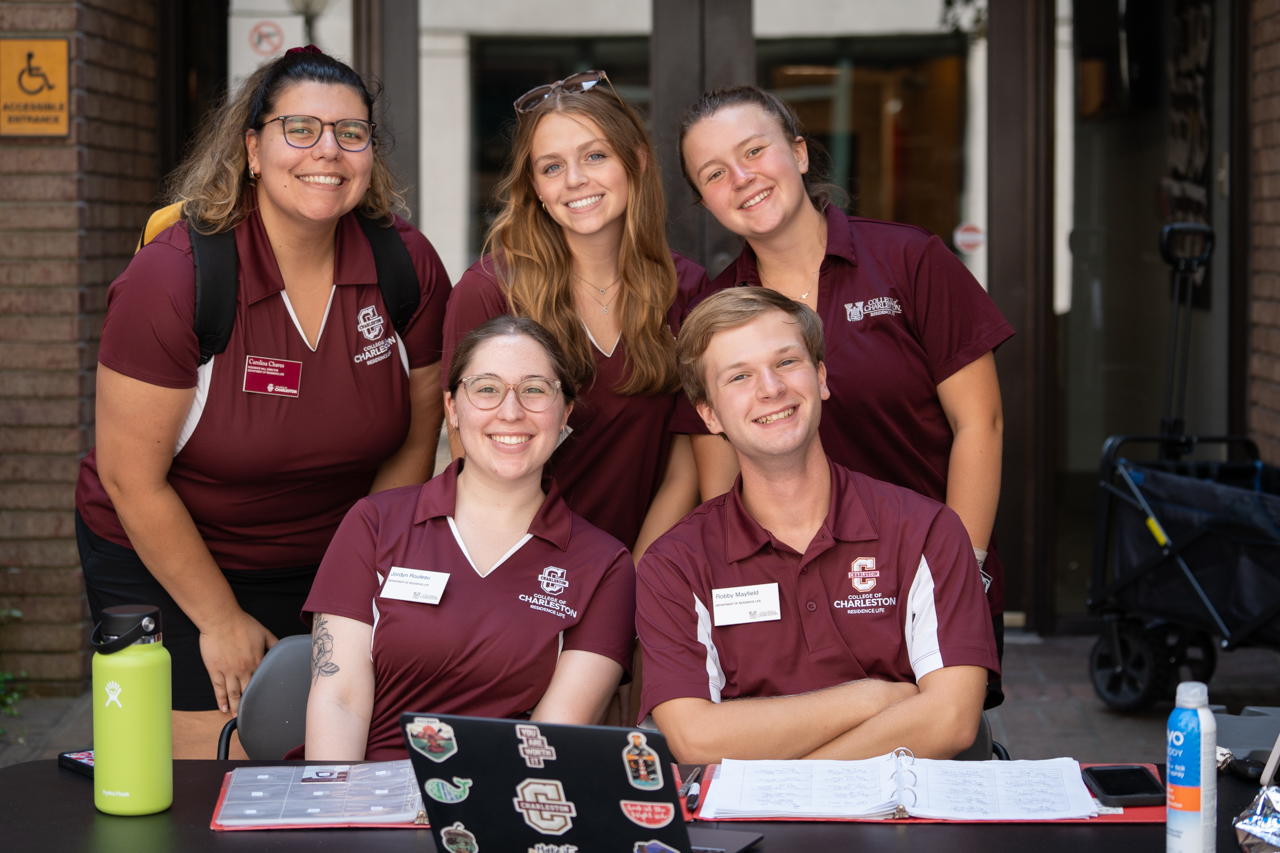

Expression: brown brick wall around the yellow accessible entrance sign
xmin=0 ymin=0 xmax=156 ymax=694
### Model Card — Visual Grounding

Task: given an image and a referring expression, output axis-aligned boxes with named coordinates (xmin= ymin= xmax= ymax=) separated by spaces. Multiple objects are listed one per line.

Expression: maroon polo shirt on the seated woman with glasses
xmin=305 ymin=460 xmax=635 ymax=761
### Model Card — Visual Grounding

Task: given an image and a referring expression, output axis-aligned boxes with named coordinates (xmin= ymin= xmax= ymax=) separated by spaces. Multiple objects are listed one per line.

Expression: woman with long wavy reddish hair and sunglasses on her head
xmin=444 ymin=72 xmax=707 ymax=557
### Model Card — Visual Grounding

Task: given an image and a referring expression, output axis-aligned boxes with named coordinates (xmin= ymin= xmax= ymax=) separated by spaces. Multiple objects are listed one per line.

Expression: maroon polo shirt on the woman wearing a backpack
xmin=76 ymin=202 xmax=449 ymax=569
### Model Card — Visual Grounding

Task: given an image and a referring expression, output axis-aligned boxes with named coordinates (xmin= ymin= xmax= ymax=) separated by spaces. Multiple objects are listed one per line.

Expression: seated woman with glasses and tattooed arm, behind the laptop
xmin=304 ymin=316 xmax=635 ymax=761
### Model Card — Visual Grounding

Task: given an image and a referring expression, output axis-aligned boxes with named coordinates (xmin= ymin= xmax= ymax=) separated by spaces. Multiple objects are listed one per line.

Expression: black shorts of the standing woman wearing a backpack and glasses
xmin=76 ymin=511 xmax=319 ymax=711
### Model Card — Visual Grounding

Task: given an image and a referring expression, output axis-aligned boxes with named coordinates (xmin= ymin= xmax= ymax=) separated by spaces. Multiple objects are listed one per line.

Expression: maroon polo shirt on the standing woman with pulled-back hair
xmin=671 ymin=205 xmax=1014 ymax=613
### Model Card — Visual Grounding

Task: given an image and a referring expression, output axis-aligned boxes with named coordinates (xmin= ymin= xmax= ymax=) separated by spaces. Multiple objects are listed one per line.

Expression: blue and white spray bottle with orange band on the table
xmin=1165 ymin=681 xmax=1217 ymax=853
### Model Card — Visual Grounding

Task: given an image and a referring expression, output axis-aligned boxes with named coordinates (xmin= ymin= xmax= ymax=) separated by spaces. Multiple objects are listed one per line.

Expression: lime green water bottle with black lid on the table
xmin=91 ymin=605 xmax=173 ymax=815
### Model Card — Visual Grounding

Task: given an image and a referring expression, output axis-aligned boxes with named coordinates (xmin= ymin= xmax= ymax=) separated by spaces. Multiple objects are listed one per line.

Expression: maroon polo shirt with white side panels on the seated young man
xmin=636 ymin=462 xmax=1000 ymax=719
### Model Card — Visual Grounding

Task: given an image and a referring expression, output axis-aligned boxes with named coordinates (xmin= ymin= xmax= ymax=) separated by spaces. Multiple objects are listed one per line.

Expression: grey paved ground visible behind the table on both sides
xmin=0 ymin=630 xmax=1280 ymax=767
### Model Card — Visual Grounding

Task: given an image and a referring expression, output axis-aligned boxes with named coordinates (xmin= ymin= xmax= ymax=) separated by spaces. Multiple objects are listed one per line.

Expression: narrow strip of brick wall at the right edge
xmin=1248 ymin=0 xmax=1280 ymax=465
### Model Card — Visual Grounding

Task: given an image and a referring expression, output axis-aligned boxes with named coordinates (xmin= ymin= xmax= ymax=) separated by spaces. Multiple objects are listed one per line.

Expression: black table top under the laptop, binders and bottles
xmin=0 ymin=761 xmax=1257 ymax=853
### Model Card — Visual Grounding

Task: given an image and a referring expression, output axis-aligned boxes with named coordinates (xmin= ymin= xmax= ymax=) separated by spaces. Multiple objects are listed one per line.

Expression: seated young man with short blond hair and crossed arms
xmin=636 ymin=287 xmax=1000 ymax=763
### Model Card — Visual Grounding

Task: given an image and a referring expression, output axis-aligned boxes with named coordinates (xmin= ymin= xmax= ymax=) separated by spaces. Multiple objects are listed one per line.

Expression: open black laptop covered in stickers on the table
xmin=401 ymin=713 xmax=763 ymax=853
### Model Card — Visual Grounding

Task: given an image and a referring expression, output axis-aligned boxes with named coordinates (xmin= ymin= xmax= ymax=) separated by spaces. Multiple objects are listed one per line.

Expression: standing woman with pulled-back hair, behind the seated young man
xmin=672 ymin=86 xmax=1014 ymax=707
